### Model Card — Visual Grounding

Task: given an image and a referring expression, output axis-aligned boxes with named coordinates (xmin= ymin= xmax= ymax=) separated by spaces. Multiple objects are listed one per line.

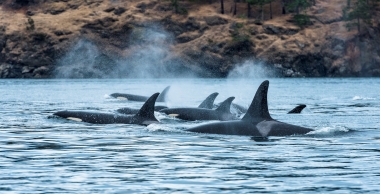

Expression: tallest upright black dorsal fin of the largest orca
xmin=242 ymin=80 xmax=272 ymax=121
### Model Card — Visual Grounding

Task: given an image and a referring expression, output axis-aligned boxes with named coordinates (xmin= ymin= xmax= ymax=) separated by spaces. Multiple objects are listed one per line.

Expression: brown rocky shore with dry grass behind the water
xmin=0 ymin=0 xmax=380 ymax=78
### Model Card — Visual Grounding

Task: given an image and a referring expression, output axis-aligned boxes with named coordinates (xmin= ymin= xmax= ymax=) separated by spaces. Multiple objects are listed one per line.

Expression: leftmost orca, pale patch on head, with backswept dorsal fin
xmin=53 ymin=93 xmax=160 ymax=125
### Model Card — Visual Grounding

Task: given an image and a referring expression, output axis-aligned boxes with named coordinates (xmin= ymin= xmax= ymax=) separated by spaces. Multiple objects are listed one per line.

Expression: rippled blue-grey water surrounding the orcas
xmin=0 ymin=78 xmax=380 ymax=193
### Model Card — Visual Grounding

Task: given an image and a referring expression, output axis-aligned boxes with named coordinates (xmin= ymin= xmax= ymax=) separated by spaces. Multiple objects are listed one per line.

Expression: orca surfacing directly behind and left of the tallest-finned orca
xmin=159 ymin=97 xmax=237 ymax=121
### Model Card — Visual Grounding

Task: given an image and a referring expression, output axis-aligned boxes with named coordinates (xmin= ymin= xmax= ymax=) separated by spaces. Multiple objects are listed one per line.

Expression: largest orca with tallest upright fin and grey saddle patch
xmin=186 ymin=80 xmax=313 ymax=137
